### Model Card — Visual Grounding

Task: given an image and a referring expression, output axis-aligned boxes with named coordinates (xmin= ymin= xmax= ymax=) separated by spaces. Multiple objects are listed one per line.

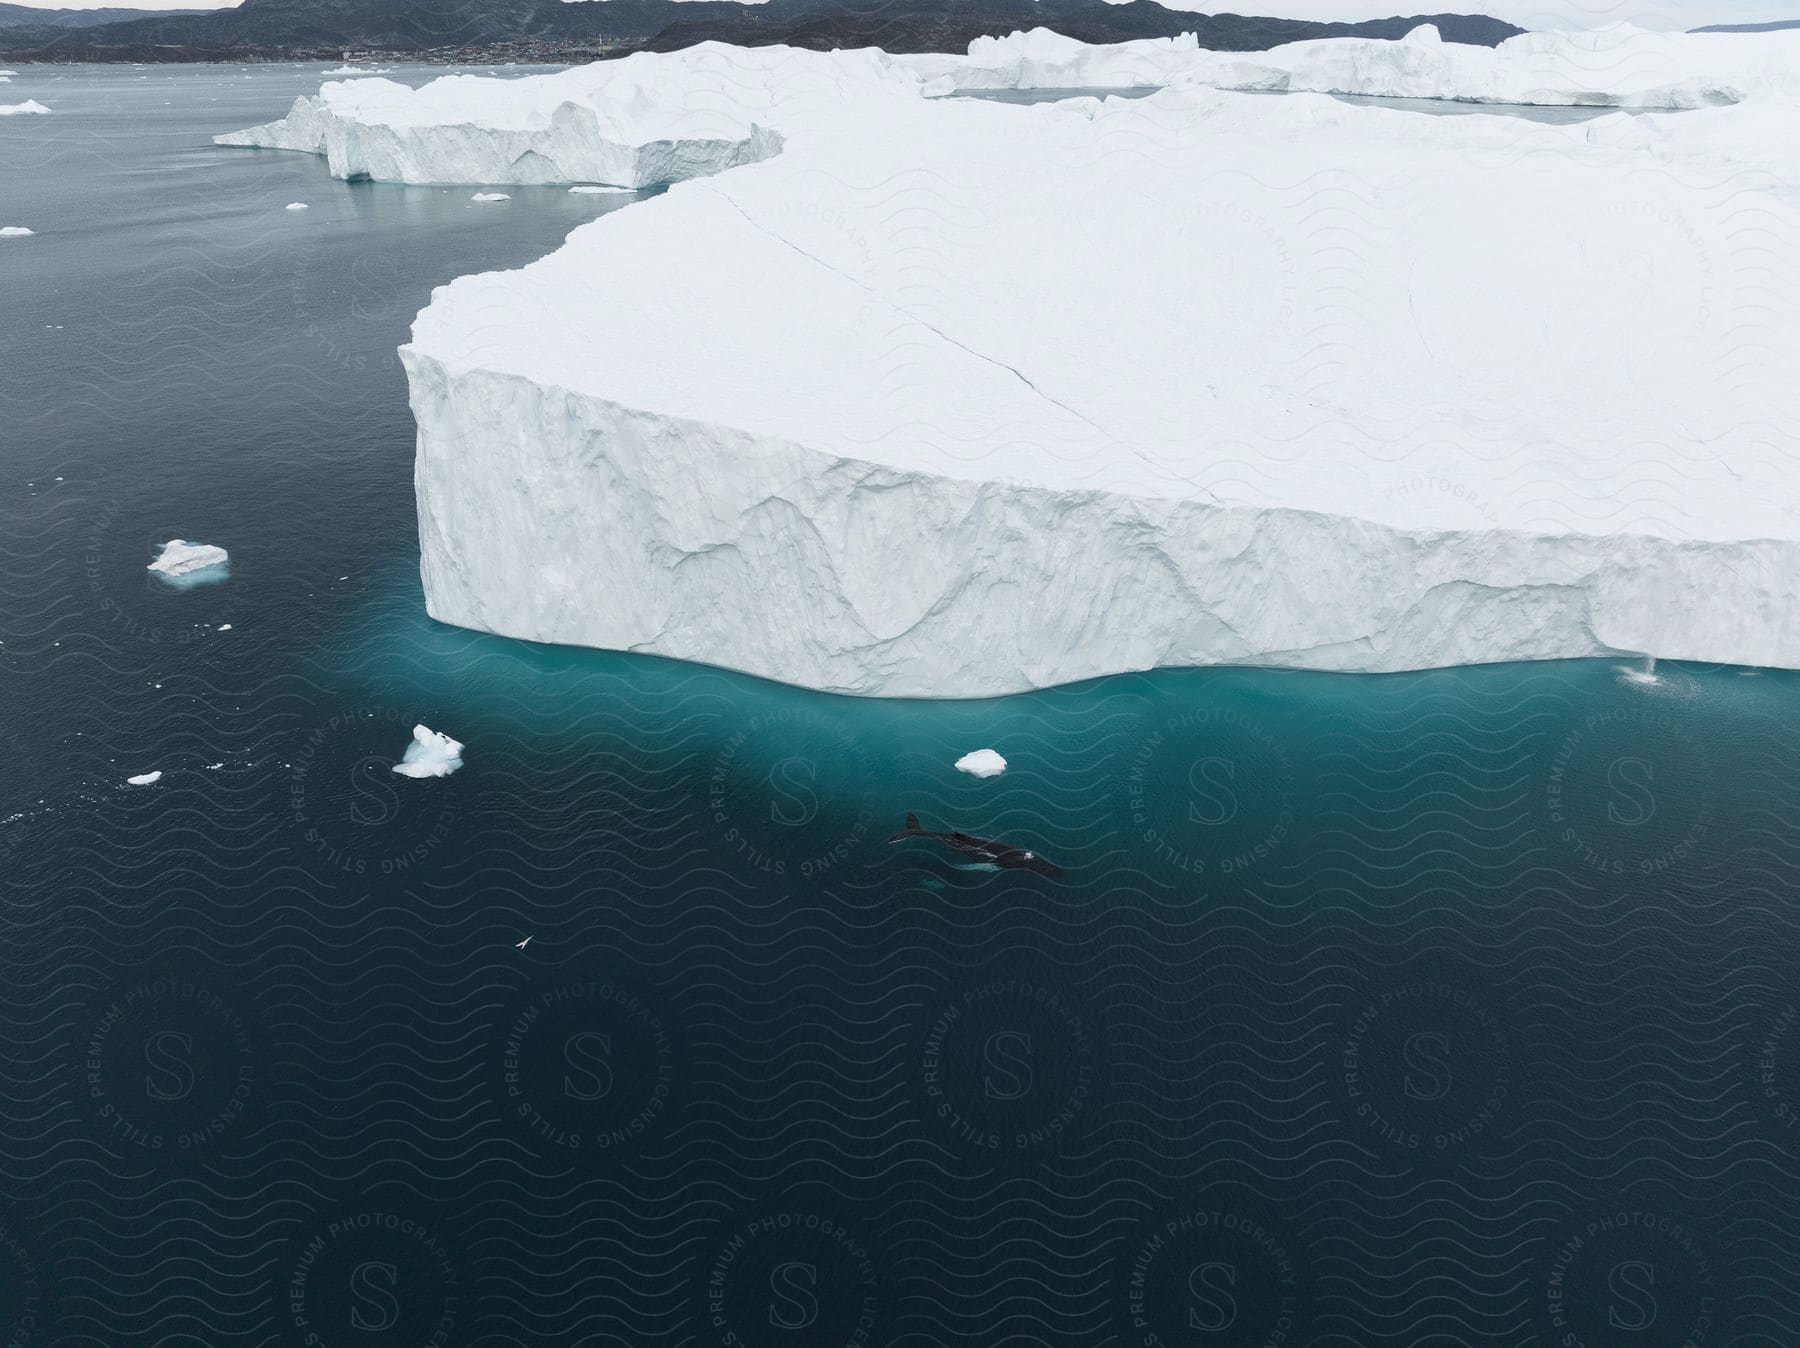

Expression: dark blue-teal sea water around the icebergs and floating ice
xmin=0 ymin=67 xmax=1800 ymax=1348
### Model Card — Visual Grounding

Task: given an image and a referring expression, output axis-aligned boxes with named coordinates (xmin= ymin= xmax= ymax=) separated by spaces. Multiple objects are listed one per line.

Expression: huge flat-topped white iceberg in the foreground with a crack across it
xmin=403 ymin=54 xmax=1800 ymax=696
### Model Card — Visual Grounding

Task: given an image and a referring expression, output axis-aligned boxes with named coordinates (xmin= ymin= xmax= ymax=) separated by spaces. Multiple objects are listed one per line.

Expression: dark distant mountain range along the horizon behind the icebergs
xmin=0 ymin=0 xmax=1521 ymax=63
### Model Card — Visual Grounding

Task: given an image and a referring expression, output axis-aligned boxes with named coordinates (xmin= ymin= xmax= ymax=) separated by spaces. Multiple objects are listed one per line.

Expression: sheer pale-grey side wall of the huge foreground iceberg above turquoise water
xmin=407 ymin=349 xmax=1800 ymax=696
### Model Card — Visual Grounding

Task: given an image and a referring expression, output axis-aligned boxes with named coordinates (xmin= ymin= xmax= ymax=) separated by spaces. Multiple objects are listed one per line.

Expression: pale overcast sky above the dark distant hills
xmin=11 ymin=0 xmax=1800 ymax=29
